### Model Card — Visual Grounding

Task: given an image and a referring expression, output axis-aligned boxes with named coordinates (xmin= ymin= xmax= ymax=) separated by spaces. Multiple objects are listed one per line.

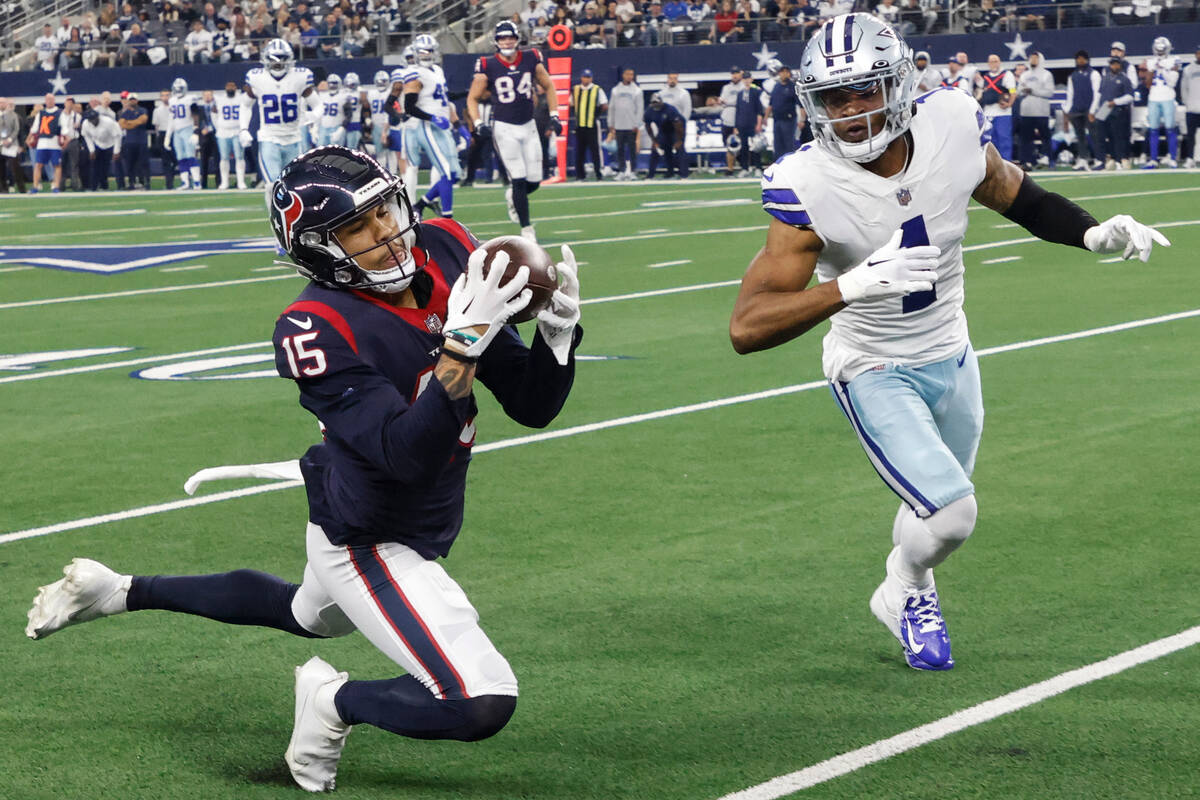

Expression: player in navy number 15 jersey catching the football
xmin=25 ymin=146 xmax=582 ymax=792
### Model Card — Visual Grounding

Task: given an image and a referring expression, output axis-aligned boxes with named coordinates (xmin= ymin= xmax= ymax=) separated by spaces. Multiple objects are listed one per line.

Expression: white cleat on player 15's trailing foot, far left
xmin=25 ymin=559 xmax=133 ymax=639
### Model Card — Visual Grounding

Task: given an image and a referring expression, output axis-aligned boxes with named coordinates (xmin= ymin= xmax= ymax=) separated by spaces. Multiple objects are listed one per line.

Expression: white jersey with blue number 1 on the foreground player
xmin=762 ymin=89 xmax=986 ymax=380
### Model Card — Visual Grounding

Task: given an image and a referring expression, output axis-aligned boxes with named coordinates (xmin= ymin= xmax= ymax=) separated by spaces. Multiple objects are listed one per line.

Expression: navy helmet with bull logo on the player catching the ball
xmin=271 ymin=145 xmax=420 ymax=293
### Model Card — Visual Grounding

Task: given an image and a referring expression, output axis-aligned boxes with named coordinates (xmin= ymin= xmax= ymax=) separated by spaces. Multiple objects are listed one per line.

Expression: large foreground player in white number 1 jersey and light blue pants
xmin=730 ymin=13 xmax=1169 ymax=669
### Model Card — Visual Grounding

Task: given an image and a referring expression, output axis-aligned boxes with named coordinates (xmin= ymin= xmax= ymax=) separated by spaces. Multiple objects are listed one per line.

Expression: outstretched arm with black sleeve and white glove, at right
xmin=973 ymin=144 xmax=1171 ymax=261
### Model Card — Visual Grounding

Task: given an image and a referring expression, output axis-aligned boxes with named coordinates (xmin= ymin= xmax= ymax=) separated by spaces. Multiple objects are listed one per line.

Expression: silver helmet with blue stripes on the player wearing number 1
xmin=796 ymin=13 xmax=919 ymax=162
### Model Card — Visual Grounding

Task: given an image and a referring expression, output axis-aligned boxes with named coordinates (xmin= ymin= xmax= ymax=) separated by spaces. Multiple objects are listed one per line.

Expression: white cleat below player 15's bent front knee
xmin=283 ymin=656 xmax=350 ymax=792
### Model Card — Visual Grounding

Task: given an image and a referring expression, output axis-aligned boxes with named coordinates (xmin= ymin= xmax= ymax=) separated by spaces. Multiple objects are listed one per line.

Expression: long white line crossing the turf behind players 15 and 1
xmin=0 ymin=308 xmax=1200 ymax=545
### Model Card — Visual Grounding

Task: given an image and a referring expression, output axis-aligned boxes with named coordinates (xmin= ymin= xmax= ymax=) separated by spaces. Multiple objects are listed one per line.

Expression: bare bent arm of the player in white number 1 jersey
xmin=730 ymin=219 xmax=846 ymax=353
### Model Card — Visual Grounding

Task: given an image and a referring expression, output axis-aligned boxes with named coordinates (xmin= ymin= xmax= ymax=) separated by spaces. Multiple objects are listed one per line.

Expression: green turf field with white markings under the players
xmin=0 ymin=172 xmax=1200 ymax=800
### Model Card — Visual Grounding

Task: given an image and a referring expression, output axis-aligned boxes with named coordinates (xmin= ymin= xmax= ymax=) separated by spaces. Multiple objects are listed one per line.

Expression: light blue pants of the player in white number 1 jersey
xmin=830 ymin=344 xmax=983 ymax=517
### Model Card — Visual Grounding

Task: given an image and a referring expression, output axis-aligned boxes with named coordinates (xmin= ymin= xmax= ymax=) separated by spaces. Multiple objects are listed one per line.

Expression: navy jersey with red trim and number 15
xmin=274 ymin=219 xmax=582 ymax=558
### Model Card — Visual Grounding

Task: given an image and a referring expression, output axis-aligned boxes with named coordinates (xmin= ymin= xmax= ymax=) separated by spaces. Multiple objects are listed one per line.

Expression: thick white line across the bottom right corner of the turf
xmin=720 ymin=625 xmax=1200 ymax=800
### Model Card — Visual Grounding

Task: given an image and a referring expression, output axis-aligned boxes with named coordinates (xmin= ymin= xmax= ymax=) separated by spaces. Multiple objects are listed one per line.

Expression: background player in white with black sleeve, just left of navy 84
xmin=403 ymin=34 xmax=458 ymax=217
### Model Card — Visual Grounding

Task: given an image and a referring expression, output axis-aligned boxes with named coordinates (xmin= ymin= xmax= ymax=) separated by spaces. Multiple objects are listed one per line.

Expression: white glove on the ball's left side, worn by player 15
xmin=442 ymin=247 xmax=533 ymax=359
